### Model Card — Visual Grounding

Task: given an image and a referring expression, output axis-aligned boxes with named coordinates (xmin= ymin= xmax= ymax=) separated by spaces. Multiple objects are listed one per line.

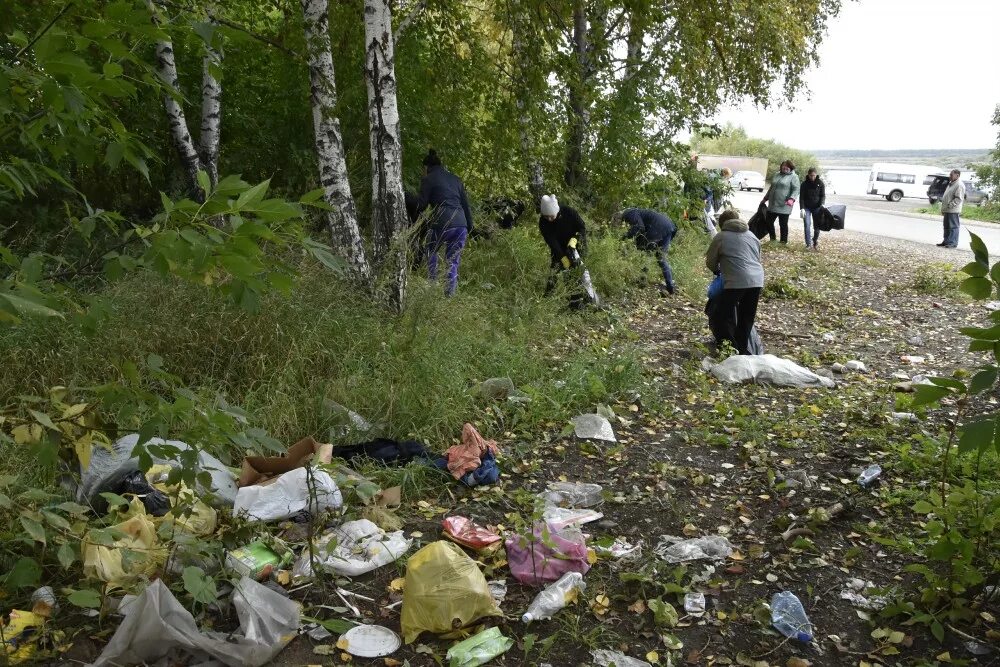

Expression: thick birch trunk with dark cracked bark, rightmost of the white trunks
xmin=364 ymin=0 xmax=407 ymax=311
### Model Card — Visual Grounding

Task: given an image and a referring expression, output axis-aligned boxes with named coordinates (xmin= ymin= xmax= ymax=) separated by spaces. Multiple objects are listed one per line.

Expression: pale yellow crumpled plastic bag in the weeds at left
xmin=82 ymin=498 xmax=167 ymax=586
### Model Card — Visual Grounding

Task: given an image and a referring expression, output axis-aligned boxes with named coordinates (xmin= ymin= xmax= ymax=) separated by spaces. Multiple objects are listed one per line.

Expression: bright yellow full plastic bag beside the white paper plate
xmin=401 ymin=540 xmax=503 ymax=644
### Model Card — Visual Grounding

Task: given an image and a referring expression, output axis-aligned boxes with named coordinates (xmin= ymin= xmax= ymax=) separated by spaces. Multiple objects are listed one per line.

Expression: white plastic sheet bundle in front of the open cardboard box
xmin=233 ymin=468 xmax=344 ymax=521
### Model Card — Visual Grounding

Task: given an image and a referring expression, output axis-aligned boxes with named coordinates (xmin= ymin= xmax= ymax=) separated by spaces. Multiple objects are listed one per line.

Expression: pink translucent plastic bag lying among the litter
xmin=506 ymin=522 xmax=590 ymax=586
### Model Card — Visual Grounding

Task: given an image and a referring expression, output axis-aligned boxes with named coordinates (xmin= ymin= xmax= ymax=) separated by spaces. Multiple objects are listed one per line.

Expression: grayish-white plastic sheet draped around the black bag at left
xmin=76 ymin=433 xmax=236 ymax=516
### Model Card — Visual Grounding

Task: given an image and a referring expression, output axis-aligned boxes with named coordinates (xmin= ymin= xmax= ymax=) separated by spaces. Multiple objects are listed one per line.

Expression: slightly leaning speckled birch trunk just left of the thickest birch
xmin=301 ymin=0 xmax=371 ymax=285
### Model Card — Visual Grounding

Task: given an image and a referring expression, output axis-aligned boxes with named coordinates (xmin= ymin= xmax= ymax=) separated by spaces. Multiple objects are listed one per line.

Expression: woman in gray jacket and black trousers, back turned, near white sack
xmin=705 ymin=210 xmax=764 ymax=354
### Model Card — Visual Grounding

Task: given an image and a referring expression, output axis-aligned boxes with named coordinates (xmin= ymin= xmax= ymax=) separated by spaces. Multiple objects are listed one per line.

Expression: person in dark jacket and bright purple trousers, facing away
xmin=416 ymin=153 xmax=472 ymax=296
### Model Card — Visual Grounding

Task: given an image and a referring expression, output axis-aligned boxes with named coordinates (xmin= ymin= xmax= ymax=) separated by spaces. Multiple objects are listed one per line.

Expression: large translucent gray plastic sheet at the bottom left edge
xmin=94 ymin=577 xmax=299 ymax=667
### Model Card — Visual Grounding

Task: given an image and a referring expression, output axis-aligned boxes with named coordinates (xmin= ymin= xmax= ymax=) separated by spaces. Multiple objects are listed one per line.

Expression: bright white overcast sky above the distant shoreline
xmin=715 ymin=0 xmax=1000 ymax=150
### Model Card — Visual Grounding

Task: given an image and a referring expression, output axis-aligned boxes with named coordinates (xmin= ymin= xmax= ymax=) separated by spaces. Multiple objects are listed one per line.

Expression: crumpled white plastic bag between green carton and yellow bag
xmin=293 ymin=519 xmax=413 ymax=579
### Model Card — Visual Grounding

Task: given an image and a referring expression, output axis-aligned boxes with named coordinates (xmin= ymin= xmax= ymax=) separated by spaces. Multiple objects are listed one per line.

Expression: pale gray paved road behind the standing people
xmin=733 ymin=192 xmax=1000 ymax=257
